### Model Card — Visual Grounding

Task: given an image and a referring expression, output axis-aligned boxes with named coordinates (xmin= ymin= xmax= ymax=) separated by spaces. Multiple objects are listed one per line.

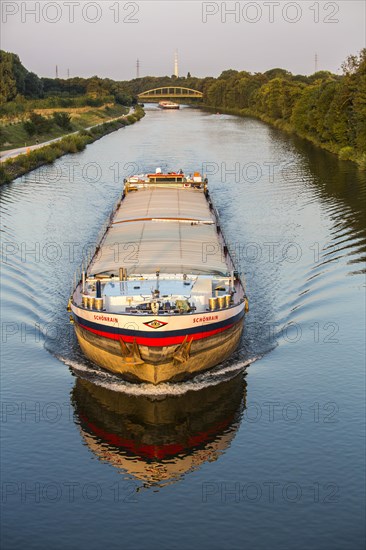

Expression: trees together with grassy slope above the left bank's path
xmin=0 ymin=51 xmax=135 ymax=150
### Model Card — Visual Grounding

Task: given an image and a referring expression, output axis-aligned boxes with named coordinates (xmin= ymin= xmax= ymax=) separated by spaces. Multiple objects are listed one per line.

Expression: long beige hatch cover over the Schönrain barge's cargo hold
xmin=88 ymin=185 xmax=229 ymax=276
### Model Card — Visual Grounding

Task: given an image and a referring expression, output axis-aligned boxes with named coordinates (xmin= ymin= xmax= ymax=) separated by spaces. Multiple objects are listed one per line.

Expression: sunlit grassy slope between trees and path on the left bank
xmin=0 ymin=102 xmax=128 ymax=151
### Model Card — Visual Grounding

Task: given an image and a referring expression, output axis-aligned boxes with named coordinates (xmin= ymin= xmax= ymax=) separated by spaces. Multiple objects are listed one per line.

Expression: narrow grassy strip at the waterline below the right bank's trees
xmin=201 ymin=105 xmax=366 ymax=170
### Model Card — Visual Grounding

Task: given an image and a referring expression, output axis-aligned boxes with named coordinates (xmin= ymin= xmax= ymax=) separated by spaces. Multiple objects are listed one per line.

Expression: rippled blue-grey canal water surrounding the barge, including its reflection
xmin=0 ymin=105 xmax=366 ymax=550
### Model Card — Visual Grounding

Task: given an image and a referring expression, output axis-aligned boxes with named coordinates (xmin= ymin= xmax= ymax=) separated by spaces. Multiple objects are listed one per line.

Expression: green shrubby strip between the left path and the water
xmin=0 ymin=107 xmax=145 ymax=184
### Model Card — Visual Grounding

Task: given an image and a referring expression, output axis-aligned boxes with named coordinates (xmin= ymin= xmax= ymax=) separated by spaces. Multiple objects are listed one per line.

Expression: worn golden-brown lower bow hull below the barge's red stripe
xmin=75 ymin=319 xmax=243 ymax=384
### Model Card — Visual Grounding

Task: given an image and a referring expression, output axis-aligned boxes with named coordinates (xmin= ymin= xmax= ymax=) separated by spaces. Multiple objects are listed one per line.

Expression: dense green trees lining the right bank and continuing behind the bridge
xmin=125 ymin=49 xmax=366 ymax=168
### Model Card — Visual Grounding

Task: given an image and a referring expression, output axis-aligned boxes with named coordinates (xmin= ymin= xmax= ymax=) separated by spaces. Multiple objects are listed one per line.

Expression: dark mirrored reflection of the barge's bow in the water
xmin=72 ymin=373 xmax=246 ymax=486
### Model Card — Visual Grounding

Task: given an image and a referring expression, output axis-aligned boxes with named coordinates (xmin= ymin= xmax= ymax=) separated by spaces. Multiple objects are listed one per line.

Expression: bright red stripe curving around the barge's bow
xmin=78 ymin=321 xmax=236 ymax=347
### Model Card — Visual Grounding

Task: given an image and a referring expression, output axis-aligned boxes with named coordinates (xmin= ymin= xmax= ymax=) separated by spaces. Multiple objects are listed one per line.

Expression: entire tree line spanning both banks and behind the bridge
xmin=0 ymin=49 xmax=366 ymax=168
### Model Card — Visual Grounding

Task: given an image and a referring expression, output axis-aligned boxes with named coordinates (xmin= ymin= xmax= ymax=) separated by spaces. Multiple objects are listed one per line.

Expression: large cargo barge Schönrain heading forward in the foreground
xmin=68 ymin=168 xmax=248 ymax=384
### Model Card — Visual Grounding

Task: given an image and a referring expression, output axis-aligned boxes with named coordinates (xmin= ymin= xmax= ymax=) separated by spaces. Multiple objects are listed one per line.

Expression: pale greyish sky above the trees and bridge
xmin=1 ymin=0 xmax=366 ymax=80
